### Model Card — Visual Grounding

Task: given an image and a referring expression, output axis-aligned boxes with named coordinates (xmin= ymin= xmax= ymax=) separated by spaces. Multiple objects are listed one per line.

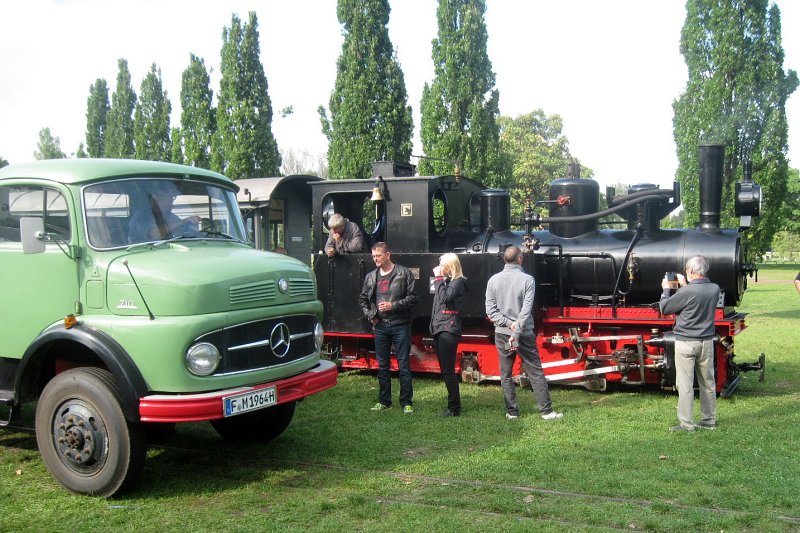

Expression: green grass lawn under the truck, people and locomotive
xmin=0 ymin=265 xmax=800 ymax=532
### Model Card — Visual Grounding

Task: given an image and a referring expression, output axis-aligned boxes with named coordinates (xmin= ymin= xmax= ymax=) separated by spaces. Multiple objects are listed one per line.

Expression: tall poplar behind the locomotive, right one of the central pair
xmin=419 ymin=0 xmax=507 ymax=186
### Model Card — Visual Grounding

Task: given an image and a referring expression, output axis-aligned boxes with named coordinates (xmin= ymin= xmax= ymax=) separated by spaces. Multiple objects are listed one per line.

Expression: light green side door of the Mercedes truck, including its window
xmin=0 ymin=185 xmax=79 ymax=358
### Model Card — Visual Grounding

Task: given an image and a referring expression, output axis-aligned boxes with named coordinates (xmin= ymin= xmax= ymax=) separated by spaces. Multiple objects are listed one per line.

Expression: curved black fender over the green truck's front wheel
xmin=14 ymin=323 xmax=148 ymax=422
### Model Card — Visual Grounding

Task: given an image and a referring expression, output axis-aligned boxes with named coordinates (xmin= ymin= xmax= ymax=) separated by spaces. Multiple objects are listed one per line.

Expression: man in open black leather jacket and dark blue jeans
xmin=358 ymin=242 xmax=417 ymax=414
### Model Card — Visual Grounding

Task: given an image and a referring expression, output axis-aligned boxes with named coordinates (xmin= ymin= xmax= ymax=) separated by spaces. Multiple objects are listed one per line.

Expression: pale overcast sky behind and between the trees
xmin=0 ymin=0 xmax=800 ymax=186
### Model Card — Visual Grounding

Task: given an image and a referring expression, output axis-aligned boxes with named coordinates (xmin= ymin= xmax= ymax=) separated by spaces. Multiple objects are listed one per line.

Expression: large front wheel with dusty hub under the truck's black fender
xmin=36 ymin=367 xmax=147 ymax=497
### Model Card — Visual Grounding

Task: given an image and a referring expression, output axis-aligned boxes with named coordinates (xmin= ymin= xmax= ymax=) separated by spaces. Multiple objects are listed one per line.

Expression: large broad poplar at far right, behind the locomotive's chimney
xmin=673 ymin=0 xmax=798 ymax=254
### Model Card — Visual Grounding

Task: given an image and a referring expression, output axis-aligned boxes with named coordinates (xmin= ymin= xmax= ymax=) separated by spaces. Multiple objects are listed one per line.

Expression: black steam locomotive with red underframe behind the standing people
xmin=237 ymin=145 xmax=764 ymax=396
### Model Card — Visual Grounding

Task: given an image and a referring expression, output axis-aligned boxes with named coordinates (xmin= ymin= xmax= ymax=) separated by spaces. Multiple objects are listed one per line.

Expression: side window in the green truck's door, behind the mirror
xmin=0 ymin=186 xmax=72 ymax=242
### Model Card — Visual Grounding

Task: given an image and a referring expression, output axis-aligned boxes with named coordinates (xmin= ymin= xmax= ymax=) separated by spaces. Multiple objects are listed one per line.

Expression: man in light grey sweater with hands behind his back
xmin=486 ymin=246 xmax=564 ymax=420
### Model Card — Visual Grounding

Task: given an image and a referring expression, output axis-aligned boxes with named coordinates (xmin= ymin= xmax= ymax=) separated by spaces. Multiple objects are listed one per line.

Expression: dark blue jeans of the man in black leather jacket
xmin=373 ymin=320 xmax=414 ymax=406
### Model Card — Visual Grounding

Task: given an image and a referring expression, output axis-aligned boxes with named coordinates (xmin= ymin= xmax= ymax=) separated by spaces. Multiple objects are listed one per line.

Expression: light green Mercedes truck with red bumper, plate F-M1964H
xmin=0 ymin=159 xmax=337 ymax=496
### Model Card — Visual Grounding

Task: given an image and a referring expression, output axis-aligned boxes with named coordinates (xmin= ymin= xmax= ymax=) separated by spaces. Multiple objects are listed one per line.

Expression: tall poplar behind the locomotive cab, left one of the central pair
xmin=318 ymin=0 xmax=414 ymax=178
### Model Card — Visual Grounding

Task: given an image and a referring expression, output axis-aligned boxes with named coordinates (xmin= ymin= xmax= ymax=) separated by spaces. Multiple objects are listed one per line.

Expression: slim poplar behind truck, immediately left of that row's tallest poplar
xmin=181 ymin=54 xmax=216 ymax=168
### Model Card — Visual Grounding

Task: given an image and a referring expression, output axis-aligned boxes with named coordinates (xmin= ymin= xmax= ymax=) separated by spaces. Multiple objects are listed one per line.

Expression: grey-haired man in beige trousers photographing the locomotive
xmin=659 ymin=255 xmax=720 ymax=431
